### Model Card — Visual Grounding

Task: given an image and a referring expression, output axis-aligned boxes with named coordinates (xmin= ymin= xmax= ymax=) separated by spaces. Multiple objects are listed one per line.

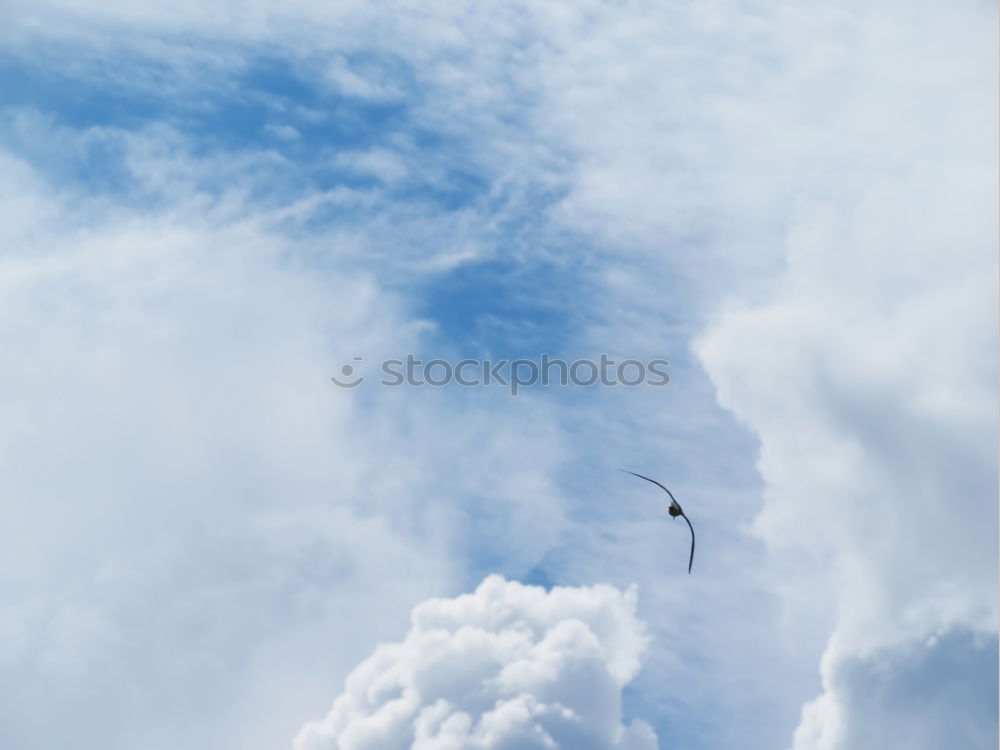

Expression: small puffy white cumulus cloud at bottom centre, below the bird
xmin=295 ymin=575 xmax=657 ymax=750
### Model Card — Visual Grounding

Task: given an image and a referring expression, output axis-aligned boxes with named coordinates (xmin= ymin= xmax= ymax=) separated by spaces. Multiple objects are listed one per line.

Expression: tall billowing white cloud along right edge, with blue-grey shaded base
xmin=697 ymin=9 xmax=997 ymax=750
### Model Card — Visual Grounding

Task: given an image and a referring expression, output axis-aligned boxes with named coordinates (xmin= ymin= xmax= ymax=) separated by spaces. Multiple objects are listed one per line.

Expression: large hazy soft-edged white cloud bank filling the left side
xmin=0 ymin=120 xmax=576 ymax=748
